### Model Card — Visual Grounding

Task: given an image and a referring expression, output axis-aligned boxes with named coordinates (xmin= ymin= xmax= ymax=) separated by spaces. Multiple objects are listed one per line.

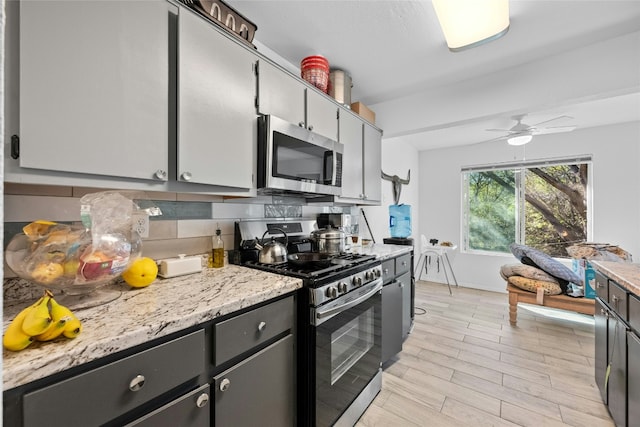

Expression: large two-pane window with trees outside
xmin=462 ymin=156 xmax=591 ymax=257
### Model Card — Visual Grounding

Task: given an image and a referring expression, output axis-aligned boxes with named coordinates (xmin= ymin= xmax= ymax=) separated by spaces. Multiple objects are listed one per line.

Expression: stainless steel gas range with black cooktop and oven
xmin=236 ymin=220 xmax=382 ymax=426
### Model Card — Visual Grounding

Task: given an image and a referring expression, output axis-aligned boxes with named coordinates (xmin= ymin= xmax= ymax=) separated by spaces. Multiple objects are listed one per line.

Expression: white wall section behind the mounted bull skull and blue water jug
xmin=358 ymin=139 xmax=420 ymax=247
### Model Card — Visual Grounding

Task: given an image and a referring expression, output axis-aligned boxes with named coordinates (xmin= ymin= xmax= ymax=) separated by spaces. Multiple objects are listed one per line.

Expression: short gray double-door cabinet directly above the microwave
xmin=257 ymin=61 xmax=339 ymax=140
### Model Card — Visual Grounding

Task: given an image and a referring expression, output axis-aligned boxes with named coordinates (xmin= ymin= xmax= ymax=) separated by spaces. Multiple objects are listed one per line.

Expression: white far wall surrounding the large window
xmin=414 ymin=122 xmax=640 ymax=291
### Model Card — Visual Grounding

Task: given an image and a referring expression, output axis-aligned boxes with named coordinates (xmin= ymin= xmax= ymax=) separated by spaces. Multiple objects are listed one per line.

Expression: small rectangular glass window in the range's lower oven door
xmin=331 ymin=307 xmax=374 ymax=385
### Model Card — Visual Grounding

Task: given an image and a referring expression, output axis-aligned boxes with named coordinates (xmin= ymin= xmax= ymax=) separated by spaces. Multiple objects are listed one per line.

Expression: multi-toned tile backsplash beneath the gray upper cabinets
xmin=3 ymin=183 xmax=353 ymax=278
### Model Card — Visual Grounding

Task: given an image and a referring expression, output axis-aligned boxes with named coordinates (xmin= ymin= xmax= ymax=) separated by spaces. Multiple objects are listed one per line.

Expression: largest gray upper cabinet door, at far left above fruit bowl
xmin=18 ymin=1 xmax=170 ymax=181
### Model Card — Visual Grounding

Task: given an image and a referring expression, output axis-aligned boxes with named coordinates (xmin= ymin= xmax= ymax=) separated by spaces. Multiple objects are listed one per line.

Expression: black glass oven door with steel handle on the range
xmin=314 ymin=279 xmax=382 ymax=426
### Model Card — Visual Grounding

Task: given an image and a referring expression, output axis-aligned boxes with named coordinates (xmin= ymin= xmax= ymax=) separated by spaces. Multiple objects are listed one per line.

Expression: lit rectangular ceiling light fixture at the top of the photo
xmin=432 ymin=0 xmax=509 ymax=52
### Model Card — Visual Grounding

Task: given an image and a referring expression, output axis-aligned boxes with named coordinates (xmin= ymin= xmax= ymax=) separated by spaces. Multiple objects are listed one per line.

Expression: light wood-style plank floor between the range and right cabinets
xmin=357 ymin=281 xmax=614 ymax=427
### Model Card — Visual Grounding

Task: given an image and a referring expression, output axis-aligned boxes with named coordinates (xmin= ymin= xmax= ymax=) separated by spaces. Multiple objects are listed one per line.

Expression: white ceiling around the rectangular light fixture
xmin=227 ymin=0 xmax=640 ymax=150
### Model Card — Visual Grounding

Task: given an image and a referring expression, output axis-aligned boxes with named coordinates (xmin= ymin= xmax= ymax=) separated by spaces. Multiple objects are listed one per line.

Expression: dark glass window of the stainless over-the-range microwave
xmin=273 ymin=131 xmax=333 ymax=185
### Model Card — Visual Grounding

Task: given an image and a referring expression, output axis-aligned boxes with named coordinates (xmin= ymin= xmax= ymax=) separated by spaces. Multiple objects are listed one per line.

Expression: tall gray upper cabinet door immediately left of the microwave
xmin=177 ymin=8 xmax=257 ymax=188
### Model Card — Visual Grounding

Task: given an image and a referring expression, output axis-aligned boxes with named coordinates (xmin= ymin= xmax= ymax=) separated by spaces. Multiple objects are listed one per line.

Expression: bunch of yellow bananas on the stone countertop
xmin=2 ymin=290 xmax=82 ymax=351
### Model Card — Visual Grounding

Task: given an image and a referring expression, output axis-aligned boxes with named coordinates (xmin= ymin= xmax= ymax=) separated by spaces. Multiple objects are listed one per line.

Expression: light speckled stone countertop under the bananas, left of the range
xmin=3 ymin=265 xmax=302 ymax=390
